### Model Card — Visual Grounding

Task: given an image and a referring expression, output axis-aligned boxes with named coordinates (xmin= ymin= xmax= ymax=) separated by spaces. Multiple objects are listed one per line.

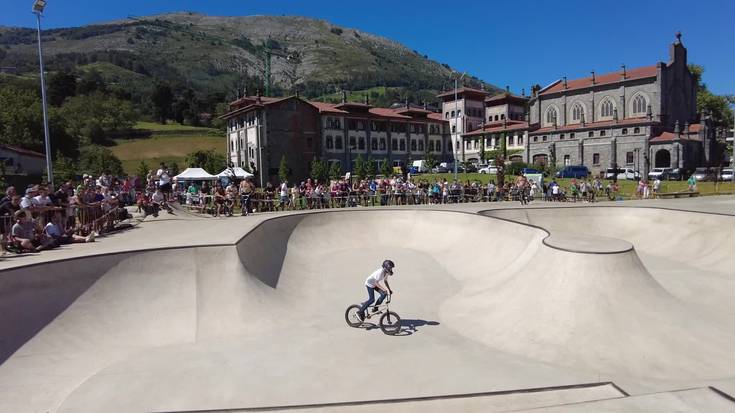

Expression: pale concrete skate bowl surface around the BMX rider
xmin=0 ymin=210 xmax=735 ymax=412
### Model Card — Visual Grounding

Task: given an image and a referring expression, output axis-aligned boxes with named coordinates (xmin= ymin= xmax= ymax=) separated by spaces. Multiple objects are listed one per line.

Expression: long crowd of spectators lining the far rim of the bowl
xmin=173 ymin=175 xmax=648 ymax=216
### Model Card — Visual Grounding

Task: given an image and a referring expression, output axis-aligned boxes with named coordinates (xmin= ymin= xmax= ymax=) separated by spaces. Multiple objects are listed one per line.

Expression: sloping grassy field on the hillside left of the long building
xmin=110 ymin=122 xmax=225 ymax=174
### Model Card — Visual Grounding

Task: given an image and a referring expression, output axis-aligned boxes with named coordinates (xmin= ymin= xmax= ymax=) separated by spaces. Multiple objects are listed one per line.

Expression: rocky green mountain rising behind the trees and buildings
xmin=0 ymin=13 xmax=499 ymax=104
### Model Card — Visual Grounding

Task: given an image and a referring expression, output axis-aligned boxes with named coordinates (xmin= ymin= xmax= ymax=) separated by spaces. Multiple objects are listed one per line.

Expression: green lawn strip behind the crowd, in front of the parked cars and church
xmin=414 ymin=173 xmax=735 ymax=198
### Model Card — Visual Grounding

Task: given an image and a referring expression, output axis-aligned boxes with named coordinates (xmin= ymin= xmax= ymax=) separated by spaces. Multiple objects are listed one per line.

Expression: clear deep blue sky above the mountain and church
xmin=0 ymin=0 xmax=735 ymax=94
